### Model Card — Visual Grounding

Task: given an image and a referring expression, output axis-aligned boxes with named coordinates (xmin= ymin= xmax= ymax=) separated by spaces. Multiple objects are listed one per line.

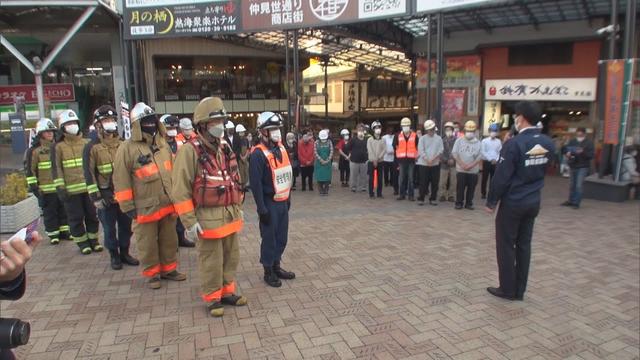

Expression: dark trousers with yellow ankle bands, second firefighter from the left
xmin=64 ymin=193 xmax=99 ymax=243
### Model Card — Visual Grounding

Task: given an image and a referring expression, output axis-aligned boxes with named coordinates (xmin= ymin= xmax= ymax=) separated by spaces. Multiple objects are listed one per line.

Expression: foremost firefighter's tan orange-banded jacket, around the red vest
xmin=172 ymin=136 xmax=243 ymax=239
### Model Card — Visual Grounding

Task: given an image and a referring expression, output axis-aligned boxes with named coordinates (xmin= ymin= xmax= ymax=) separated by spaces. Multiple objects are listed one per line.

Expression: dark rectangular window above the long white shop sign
xmin=509 ymin=42 xmax=573 ymax=66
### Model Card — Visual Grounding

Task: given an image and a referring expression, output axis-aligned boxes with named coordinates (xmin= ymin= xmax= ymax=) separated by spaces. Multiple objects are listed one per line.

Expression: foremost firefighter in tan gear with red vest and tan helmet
xmin=172 ymin=97 xmax=247 ymax=317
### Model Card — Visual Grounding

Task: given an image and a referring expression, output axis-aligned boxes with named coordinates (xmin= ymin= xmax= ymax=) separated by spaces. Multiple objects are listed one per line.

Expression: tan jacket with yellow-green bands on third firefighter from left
xmin=82 ymin=132 xmax=122 ymax=204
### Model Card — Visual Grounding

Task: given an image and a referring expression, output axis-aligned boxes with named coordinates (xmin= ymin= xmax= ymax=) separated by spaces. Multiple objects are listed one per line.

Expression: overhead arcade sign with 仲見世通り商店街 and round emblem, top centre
xmin=241 ymin=0 xmax=408 ymax=32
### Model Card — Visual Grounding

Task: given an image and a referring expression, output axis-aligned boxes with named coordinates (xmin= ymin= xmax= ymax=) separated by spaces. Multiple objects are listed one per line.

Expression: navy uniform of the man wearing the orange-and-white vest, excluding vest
xmin=249 ymin=147 xmax=290 ymax=267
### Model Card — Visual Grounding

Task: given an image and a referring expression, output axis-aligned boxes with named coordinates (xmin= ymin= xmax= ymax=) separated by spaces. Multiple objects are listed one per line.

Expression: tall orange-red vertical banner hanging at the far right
xmin=604 ymin=60 xmax=624 ymax=145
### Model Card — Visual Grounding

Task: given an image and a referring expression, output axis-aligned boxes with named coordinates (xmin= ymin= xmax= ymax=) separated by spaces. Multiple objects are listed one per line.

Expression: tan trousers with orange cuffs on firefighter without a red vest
xmin=133 ymin=215 xmax=178 ymax=277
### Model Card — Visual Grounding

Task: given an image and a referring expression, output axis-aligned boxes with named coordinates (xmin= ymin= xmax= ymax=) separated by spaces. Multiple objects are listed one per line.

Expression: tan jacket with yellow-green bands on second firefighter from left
xmin=51 ymin=134 xmax=88 ymax=195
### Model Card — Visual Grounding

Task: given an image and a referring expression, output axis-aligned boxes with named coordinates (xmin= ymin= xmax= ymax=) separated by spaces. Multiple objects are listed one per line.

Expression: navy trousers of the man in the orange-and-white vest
xmin=260 ymin=199 xmax=289 ymax=266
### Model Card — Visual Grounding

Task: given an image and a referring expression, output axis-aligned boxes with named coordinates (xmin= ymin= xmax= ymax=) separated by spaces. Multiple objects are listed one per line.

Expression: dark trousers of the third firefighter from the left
xmin=98 ymin=204 xmax=131 ymax=251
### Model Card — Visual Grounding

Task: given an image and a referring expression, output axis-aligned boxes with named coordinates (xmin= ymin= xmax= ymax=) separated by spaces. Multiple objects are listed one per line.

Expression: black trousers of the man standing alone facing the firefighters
xmin=496 ymin=203 xmax=540 ymax=297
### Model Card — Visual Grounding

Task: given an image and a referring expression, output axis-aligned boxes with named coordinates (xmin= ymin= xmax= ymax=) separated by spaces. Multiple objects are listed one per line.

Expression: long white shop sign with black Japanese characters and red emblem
xmin=485 ymin=78 xmax=597 ymax=102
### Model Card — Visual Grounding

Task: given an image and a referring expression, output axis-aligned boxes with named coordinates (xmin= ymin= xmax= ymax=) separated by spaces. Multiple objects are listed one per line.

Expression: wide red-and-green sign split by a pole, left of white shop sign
xmin=416 ymin=55 xmax=481 ymax=89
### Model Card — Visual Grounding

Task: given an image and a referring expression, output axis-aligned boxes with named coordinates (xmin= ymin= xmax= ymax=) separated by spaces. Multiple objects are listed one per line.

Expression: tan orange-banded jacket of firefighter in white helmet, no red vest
xmin=113 ymin=121 xmax=174 ymax=224
